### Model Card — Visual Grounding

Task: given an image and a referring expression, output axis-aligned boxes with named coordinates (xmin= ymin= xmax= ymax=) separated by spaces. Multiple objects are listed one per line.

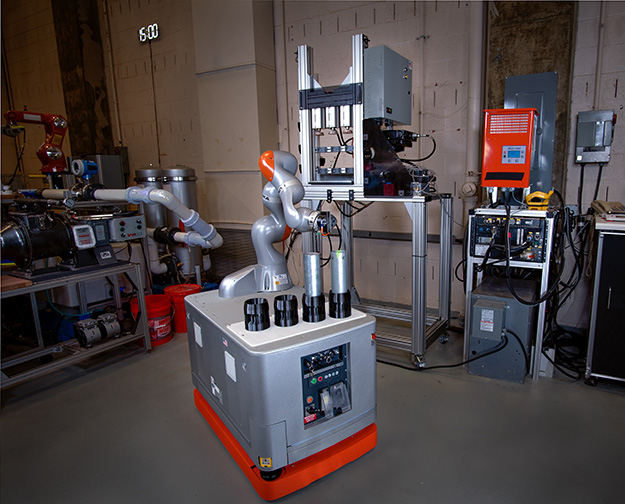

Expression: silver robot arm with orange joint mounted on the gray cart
xmin=219 ymin=151 xmax=328 ymax=298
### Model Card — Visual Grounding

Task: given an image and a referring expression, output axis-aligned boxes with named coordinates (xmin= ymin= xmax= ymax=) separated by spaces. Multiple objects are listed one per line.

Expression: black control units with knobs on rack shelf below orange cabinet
xmin=470 ymin=215 xmax=546 ymax=263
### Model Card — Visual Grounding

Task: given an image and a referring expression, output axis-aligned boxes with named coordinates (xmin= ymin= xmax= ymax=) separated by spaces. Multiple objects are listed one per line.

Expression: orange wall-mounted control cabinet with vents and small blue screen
xmin=482 ymin=109 xmax=538 ymax=188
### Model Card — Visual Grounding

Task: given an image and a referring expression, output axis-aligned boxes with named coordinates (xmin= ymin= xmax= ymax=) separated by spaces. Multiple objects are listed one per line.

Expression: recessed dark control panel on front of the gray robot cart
xmin=301 ymin=344 xmax=352 ymax=426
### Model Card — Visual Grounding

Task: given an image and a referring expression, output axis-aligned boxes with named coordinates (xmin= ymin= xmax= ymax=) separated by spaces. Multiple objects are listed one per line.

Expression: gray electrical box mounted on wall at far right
xmin=575 ymin=110 xmax=616 ymax=164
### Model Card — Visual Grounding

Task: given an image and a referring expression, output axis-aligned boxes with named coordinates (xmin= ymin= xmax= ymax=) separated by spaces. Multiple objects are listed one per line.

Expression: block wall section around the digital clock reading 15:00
xmin=101 ymin=0 xmax=203 ymax=177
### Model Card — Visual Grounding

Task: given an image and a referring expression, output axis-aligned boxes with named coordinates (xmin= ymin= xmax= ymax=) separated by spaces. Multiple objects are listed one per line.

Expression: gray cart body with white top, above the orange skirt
xmin=185 ymin=287 xmax=376 ymax=473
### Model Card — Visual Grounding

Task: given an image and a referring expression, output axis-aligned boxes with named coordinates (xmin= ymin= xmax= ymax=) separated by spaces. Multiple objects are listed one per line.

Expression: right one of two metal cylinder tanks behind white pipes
xmin=161 ymin=165 xmax=203 ymax=283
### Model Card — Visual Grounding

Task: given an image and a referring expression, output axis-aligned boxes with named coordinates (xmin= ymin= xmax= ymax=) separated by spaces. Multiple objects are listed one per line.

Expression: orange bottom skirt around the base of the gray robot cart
xmin=193 ymin=389 xmax=378 ymax=501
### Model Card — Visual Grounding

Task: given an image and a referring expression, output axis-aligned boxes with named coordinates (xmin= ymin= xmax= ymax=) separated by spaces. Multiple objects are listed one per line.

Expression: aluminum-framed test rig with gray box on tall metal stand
xmin=297 ymin=34 xmax=453 ymax=367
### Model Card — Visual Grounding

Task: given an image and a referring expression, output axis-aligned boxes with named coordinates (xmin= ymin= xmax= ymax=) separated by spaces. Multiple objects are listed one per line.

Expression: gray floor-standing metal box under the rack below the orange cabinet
xmin=469 ymin=277 xmax=536 ymax=383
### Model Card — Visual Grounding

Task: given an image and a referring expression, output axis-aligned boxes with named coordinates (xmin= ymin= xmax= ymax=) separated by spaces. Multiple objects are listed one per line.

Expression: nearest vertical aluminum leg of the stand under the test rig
xmin=406 ymin=196 xmax=428 ymax=358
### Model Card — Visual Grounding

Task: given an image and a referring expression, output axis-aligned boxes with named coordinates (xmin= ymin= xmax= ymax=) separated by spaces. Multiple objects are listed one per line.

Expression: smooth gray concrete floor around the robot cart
xmin=0 ymin=334 xmax=625 ymax=504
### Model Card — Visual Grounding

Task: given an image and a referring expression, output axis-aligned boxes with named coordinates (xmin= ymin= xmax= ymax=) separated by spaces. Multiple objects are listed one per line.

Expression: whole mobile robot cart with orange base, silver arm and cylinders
xmin=185 ymin=151 xmax=377 ymax=500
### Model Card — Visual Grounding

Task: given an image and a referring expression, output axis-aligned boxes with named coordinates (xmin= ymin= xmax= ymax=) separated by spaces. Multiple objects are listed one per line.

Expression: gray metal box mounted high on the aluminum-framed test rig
xmin=364 ymin=46 xmax=412 ymax=124
